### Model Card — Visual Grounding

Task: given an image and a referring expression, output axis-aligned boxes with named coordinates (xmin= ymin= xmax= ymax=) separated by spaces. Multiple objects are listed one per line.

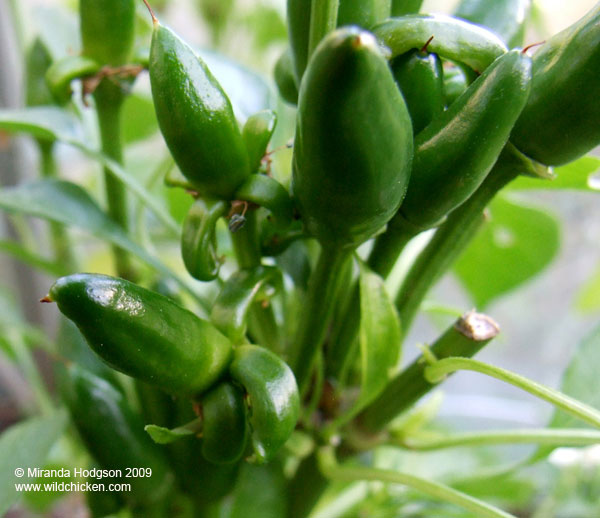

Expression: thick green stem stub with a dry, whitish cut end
xmin=357 ymin=312 xmax=498 ymax=435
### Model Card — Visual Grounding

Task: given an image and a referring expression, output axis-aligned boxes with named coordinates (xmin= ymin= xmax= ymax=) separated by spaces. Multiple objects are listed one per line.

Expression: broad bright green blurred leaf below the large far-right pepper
xmin=454 ymin=198 xmax=560 ymax=308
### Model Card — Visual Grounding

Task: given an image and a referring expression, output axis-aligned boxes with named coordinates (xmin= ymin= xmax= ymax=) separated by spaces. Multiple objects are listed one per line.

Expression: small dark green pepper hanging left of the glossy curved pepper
xmin=202 ymin=382 xmax=247 ymax=464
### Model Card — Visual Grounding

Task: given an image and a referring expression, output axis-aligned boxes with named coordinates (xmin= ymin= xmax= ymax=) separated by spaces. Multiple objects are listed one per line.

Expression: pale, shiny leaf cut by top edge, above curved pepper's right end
xmin=454 ymin=0 xmax=531 ymax=48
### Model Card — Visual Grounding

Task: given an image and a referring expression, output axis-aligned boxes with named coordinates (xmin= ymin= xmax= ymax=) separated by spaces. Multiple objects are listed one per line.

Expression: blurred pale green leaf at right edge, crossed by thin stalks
xmin=533 ymin=325 xmax=600 ymax=460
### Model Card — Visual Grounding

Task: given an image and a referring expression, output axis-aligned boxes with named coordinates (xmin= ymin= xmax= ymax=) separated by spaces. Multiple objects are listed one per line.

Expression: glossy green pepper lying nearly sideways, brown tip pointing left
xmin=49 ymin=274 xmax=231 ymax=396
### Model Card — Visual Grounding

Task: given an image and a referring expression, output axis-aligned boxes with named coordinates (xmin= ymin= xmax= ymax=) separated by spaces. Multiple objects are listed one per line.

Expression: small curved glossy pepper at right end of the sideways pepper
xmin=229 ymin=345 xmax=300 ymax=462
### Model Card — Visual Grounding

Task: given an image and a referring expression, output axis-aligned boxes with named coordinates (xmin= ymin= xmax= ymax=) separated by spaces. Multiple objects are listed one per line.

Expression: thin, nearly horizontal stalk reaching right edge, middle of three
xmin=386 ymin=428 xmax=600 ymax=451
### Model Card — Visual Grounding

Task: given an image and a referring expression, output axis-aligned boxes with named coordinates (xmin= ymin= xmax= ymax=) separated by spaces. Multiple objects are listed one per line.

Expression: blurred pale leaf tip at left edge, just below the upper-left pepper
xmin=0 ymin=106 xmax=82 ymax=142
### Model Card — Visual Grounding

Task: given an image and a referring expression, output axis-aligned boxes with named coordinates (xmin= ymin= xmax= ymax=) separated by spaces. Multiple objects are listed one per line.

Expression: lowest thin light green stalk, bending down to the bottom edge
xmin=318 ymin=446 xmax=515 ymax=518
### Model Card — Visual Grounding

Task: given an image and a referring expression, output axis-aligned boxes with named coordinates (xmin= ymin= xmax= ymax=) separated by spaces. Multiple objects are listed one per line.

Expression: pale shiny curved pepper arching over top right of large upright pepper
xmin=372 ymin=14 xmax=507 ymax=72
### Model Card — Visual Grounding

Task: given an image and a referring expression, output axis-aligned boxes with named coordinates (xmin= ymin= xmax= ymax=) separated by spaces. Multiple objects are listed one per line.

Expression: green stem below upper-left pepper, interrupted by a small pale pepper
xmin=231 ymin=210 xmax=281 ymax=352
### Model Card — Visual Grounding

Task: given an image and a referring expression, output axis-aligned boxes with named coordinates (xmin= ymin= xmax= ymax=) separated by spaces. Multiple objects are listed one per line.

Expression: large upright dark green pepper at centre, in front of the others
xmin=292 ymin=27 xmax=413 ymax=247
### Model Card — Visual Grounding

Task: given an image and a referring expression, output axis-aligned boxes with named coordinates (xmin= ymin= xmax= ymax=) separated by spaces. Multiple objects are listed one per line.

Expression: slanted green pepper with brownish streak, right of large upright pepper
xmin=394 ymin=50 xmax=531 ymax=229
